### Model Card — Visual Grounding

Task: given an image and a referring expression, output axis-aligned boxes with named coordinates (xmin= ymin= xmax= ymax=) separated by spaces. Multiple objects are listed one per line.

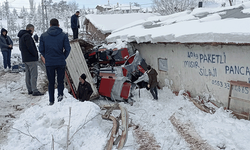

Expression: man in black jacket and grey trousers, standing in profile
xmin=17 ymin=24 xmax=43 ymax=96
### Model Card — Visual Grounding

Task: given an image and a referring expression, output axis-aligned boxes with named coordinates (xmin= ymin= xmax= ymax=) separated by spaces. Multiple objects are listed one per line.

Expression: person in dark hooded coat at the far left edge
xmin=0 ymin=28 xmax=13 ymax=72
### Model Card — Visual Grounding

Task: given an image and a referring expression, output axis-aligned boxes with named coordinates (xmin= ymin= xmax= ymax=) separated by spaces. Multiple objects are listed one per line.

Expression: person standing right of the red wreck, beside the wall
xmin=147 ymin=65 xmax=158 ymax=100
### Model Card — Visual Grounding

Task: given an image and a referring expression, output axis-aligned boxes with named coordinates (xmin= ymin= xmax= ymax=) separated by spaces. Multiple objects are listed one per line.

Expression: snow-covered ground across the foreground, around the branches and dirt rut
xmin=0 ymin=47 xmax=250 ymax=150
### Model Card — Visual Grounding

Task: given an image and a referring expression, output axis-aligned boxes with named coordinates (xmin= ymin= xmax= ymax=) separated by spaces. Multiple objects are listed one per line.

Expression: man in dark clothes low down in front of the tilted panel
xmin=77 ymin=74 xmax=93 ymax=102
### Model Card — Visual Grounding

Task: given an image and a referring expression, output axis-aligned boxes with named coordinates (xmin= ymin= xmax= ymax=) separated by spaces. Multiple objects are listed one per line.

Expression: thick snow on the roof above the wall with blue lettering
xmin=107 ymin=2 xmax=250 ymax=43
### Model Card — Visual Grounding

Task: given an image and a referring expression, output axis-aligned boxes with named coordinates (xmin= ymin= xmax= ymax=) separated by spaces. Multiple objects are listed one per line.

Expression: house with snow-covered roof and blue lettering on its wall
xmin=107 ymin=2 xmax=250 ymax=119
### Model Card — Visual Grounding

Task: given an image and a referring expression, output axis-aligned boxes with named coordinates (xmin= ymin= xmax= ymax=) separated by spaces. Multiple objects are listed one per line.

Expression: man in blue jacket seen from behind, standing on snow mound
xmin=39 ymin=19 xmax=71 ymax=105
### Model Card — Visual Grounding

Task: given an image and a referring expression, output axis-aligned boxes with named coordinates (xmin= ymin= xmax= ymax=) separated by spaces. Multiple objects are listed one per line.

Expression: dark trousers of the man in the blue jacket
xmin=46 ymin=66 xmax=65 ymax=103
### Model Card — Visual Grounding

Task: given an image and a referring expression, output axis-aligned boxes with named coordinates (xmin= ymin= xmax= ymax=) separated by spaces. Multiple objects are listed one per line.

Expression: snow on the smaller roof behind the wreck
xmin=86 ymin=13 xmax=156 ymax=34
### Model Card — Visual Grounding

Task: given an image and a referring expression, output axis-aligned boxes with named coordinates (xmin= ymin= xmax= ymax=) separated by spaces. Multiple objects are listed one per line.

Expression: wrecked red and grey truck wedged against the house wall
xmin=66 ymin=40 xmax=148 ymax=104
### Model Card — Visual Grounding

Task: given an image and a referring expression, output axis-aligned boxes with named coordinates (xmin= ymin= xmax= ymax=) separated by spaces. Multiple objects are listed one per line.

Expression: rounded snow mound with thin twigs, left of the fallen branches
xmin=1 ymin=91 xmax=107 ymax=150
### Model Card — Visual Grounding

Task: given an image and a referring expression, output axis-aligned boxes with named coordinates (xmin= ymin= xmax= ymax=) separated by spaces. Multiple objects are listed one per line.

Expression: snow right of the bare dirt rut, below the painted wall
xmin=176 ymin=107 xmax=250 ymax=150
